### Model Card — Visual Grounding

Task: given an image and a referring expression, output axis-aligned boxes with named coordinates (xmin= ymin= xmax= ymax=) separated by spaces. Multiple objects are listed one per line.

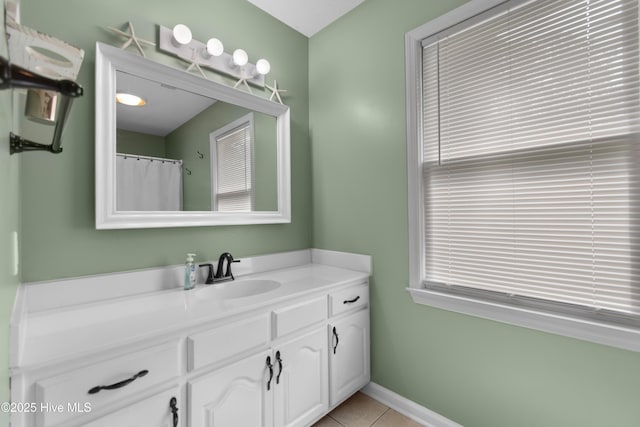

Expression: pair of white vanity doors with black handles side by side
xmin=188 ymin=328 xmax=329 ymax=427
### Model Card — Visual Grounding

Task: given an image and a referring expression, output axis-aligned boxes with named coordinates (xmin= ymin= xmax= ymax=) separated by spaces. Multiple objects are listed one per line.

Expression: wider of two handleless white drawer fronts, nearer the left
xmin=187 ymin=313 xmax=271 ymax=371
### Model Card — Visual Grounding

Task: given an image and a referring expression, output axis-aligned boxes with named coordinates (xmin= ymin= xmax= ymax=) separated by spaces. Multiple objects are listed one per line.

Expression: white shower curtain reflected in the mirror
xmin=116 ymin=153 xmax=182 ymax=211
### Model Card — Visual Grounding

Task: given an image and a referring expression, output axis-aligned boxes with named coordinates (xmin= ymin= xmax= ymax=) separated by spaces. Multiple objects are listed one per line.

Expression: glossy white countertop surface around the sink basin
xmin=11 ymin=263 xmax=370 ymax=372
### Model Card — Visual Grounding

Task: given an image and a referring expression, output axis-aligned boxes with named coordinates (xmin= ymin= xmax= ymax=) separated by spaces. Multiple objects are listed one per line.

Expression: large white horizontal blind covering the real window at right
xmin=422 ymin=0 xmax=640 ymax=322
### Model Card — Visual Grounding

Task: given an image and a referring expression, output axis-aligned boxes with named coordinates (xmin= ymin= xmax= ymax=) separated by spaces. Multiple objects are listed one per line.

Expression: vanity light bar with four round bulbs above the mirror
xmin=158 ymin=24 xmax=271 ymax=91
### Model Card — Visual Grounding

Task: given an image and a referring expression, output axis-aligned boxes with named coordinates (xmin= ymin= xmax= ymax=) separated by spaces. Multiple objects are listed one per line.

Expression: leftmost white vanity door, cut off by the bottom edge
xmin=82 ymin=387 xmax=181 ymax=427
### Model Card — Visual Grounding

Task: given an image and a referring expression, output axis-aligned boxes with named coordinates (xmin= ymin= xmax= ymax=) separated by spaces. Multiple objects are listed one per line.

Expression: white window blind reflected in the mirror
xmin=215 ymin=122 xmax=253 ymax=211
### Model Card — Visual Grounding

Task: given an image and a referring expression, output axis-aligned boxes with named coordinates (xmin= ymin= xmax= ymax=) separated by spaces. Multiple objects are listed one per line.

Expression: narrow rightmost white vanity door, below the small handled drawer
xmin=329 ymin=310 xmax=370 ymax=406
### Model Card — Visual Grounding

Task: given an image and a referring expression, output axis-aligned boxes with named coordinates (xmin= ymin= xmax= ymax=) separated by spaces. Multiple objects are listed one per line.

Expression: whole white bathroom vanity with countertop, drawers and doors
xmin=11 ymin=250 xmax=370 ymax=427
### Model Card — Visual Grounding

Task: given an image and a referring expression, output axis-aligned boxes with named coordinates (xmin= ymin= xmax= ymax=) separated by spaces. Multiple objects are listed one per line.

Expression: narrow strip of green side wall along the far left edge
xmin=0 ymin=4 xmax=20 ymax=426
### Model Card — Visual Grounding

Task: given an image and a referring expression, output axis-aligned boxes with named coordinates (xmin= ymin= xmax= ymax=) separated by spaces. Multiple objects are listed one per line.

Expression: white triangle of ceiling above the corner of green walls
xmin=248 ymin=0 xmax=364 ymax=37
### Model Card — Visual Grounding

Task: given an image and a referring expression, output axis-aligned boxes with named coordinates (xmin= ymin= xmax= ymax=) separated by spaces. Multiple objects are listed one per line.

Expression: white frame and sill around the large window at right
xmin=405 ymin=0 xmax=640 ymax=351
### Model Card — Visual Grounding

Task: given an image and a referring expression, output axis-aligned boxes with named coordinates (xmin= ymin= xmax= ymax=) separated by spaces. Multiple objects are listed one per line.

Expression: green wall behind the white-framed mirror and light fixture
xmin=20 ymin=0 xmax=312 ymax=282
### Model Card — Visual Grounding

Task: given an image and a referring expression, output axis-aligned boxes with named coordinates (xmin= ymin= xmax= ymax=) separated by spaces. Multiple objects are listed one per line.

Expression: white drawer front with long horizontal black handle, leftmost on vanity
xmin=35 ymin=341 xmax=180 ymax=427
